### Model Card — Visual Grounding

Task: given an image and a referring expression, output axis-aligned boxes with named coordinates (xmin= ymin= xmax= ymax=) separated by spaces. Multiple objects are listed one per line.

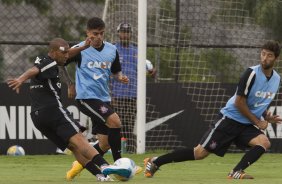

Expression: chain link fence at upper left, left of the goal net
xmin=0 ymin=0 xmax=104 ymax=82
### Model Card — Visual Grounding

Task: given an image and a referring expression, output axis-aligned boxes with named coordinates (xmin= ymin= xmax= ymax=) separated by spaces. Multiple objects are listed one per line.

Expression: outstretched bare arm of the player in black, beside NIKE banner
xmin=7 ymin=66 xmax=39 ymax=93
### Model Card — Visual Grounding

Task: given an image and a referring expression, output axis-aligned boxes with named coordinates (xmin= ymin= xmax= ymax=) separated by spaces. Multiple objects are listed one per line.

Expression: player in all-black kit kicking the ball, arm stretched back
xmin=7 ymin=38 xmax=129 ymax=180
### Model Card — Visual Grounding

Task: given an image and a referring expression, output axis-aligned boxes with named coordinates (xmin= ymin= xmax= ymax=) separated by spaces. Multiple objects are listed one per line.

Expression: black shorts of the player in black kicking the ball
xmin=30 ymin=107 xmax=85 ymax=150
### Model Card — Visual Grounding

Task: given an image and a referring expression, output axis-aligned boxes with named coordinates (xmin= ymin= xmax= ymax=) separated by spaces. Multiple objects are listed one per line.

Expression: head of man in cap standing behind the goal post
xmin=117 ymin=23 xmax=132 ymax=45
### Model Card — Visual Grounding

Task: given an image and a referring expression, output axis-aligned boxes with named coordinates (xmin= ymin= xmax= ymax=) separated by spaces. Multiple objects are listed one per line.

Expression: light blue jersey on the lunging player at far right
xmin=220 ymin=65 xmax=280 ymax=124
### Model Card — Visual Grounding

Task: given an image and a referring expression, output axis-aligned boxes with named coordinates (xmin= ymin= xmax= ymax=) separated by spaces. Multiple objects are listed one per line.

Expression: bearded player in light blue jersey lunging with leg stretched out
xmin=144 ymin=41 xmax=282 ymax=179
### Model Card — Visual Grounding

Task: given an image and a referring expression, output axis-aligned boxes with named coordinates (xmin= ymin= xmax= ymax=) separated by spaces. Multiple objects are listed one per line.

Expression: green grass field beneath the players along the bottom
xmin=0 ymin=153 xmax=282 ymax=184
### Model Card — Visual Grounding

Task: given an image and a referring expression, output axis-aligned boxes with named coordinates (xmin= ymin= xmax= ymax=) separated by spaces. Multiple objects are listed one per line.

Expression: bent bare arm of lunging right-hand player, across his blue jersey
xmin=235 ymin=95 xmax=268 ymax=130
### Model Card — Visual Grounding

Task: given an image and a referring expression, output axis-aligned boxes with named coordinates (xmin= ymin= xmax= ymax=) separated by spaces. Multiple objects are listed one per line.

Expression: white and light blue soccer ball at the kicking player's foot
xmin=114 ymin=158 xmax=136 ymax=181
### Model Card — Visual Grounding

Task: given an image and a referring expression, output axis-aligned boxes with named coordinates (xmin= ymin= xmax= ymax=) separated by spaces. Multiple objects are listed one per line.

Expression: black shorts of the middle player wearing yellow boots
xmin=77 ymin=99 xmax=115 ymax=135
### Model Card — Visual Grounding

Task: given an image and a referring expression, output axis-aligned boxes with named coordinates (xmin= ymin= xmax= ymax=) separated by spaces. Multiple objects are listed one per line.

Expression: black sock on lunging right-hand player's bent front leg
xmin=233 ymin=145 xmax=266 ymax=171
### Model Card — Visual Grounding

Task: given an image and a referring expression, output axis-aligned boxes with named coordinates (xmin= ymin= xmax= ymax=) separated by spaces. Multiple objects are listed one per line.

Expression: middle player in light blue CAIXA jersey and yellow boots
xmin=63 ymin=17 xmax=135 ymax=180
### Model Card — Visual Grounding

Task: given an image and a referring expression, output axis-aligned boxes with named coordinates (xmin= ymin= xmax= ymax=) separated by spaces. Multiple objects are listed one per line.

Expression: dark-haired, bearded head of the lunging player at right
xmin=260 ymin=41 xmax=281 ymax=70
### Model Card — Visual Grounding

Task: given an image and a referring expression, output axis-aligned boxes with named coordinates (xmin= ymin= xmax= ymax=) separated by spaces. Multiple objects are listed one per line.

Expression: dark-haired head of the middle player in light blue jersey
xmin=86 ymin=17 xmax=105 ymax=48
